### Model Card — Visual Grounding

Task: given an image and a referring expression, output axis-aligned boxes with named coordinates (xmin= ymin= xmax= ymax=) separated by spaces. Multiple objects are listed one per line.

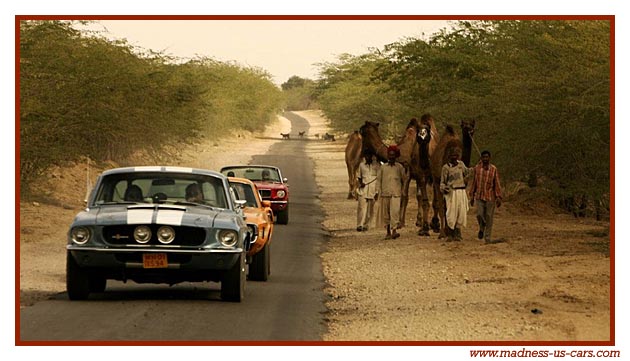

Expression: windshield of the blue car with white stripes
xmin=94 ymin=172 xmax=229 ymax=208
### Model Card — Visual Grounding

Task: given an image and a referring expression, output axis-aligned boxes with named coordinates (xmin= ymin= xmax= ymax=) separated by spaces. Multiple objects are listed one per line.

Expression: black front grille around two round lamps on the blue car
xmin=103 ymin=224 xmax=206 ymax=247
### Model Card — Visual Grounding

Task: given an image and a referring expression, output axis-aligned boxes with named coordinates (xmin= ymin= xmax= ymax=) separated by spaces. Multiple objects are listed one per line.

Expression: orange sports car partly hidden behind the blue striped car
xmin=228 ymin=177 xmax=274 ymax=281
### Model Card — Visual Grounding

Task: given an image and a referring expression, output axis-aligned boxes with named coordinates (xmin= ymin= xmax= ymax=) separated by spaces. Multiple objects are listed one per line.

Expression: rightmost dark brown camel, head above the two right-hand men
xmin=431 ymin=120 xmax=475 ymax=238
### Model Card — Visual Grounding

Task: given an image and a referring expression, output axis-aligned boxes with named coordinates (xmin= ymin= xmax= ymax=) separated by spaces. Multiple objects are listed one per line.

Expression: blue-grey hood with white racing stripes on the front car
xmin=74 ymin=204 xmax=237 ymax=228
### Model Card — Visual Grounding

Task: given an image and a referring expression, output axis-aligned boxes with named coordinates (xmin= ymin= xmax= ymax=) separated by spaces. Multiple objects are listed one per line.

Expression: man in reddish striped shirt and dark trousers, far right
xmin=470 ymin=150 xmax=501 ymax=243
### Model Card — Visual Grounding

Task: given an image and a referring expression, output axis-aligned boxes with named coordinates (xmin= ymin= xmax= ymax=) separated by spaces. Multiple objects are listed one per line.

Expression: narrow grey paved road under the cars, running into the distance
xmin=20 ymin=113 xmax=326 ymax=343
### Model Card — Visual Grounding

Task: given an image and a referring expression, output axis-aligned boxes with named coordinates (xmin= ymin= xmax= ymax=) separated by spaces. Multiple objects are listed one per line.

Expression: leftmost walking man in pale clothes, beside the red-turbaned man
xmin=357 ymin=150 xmax=381 ymax=232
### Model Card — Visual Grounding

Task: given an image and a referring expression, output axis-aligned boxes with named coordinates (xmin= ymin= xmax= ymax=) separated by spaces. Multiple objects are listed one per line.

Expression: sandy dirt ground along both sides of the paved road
xmin=20 ymin=111 xmax=610 ymax=341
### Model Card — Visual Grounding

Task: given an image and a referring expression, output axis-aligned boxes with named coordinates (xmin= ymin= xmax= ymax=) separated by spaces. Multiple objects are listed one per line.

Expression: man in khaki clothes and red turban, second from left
xmin=378 ymin=145 xmax=405 ymax=239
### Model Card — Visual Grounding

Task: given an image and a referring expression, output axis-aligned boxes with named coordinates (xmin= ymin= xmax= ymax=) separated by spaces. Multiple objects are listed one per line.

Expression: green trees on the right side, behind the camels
xmin=284 ymin=20 xmax=611 ymax=218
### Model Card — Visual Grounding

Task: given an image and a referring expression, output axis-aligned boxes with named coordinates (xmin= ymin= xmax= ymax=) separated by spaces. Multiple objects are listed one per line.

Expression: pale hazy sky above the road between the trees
xmin=82 ymin=20 xmax=448 ymax=84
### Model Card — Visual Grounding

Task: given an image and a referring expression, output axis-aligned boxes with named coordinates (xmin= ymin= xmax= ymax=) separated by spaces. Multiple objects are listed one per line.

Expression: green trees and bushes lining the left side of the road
xmin=19 ymin=21 xmax=283 ymax=193
